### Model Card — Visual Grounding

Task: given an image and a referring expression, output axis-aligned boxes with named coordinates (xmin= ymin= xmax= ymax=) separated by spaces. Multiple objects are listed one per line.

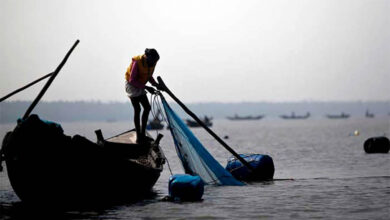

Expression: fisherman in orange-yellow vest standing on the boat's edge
xmin=125 ymin=48 xmax=162 ymax=143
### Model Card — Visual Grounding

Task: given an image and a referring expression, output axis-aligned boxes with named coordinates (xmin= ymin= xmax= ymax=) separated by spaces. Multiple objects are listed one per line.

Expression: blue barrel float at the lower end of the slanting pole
xmin=226 ymin=154 xmax=275 ymax=181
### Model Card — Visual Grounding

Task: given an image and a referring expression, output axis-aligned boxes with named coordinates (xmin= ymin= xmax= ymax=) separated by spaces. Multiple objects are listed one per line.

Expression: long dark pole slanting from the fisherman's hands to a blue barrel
xmin=157 ymin=76 xmax=253 ymax=171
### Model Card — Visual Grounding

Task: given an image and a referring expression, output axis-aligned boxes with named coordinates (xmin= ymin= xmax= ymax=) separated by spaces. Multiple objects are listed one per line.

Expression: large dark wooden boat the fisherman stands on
xmin=1 ymin=115 xmax=165 ymax=207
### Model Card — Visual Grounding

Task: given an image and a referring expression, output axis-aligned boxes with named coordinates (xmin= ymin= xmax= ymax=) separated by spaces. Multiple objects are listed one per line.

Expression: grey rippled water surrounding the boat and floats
xmin=0 ymin=117 xmax=390 ymax=219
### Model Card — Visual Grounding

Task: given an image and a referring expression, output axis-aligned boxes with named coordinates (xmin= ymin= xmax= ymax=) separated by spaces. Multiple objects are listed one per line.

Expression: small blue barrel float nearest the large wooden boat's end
xmin=168 ymin=174 xmax=204 ymax=201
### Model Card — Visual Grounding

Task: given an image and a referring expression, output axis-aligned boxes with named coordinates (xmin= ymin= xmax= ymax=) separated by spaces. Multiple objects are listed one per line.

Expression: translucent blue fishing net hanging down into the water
xmin=161 ymin=96 xmax=244 ymax=186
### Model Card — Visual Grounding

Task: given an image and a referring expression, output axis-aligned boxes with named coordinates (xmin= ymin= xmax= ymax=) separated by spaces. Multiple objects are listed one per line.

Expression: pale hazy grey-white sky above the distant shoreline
xmin=0 ymin=0 xmax=390 ymax=103
